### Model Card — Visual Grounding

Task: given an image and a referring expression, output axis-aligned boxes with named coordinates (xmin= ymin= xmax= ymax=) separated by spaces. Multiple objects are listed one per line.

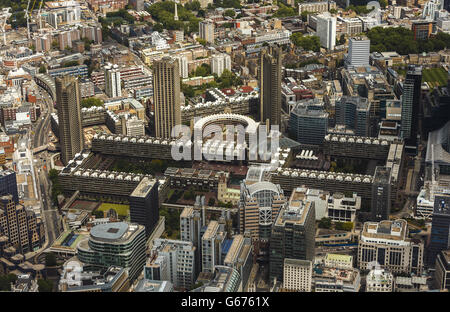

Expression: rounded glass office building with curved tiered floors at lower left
xmin=77 ymin=222 xmax=146 ymax=282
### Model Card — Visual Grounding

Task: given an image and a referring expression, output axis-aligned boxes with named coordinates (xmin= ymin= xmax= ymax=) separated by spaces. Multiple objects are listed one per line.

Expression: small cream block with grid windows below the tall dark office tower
xmin=283 ymin=258 xmax=312 ymax=292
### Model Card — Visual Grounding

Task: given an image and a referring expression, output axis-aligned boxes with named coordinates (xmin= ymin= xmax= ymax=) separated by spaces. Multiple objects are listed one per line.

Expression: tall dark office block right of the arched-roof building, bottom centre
xmin=270 ymin=186 xmax=315 ymax=281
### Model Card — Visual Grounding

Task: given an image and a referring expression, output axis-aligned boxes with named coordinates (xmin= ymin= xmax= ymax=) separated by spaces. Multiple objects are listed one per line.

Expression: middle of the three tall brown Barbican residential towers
xmin=153 ymin=57 xmax=181 ymax=138
